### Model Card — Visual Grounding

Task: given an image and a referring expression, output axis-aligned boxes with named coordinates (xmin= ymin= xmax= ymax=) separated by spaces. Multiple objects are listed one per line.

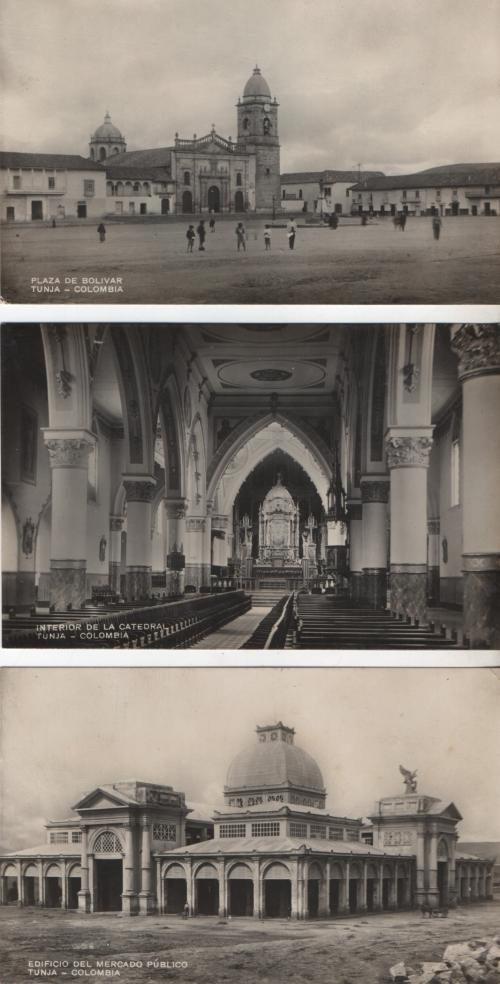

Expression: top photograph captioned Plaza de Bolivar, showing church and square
xmin=0 ymin=0 xmax=500 ymax=305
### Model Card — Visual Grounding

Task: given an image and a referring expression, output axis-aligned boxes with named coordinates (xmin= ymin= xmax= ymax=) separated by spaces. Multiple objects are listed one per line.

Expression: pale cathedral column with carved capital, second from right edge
xmin=386 ymin=427 xmax=432 ymax=622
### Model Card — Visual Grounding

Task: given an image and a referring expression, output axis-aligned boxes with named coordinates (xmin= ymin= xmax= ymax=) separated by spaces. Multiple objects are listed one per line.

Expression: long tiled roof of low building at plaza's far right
xmin=353 ymin=164 xmax=500 ymax=191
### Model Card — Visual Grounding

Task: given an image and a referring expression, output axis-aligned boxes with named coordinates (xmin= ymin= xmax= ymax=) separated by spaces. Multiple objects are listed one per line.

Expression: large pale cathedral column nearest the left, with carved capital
xmin=43 ymin=428 xmax=95 ymax=611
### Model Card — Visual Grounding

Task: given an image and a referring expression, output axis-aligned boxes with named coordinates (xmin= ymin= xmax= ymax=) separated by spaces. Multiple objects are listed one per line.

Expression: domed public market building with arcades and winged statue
xmin=0 ymin=721 xmax=494 ymax=919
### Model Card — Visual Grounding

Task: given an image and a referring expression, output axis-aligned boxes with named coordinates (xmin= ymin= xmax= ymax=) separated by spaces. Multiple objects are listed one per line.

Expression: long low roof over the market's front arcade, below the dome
xmin=164 ymin=837 xmax=411 ymax=858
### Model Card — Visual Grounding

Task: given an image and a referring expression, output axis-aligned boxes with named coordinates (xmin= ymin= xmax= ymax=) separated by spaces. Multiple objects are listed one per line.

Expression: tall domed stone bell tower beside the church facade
xmin=237 ymin=66 xmax=281 ymax=212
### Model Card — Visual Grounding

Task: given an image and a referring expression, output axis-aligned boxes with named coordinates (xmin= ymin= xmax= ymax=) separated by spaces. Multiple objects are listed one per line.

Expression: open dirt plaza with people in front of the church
xmin=2 ymin=217 xmax=500 ymax=304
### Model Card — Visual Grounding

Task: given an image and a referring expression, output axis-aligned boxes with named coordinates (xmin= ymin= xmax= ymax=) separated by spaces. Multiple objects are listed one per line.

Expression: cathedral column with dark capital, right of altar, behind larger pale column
xmin=361 ymin=476 xmax=389 ymax=608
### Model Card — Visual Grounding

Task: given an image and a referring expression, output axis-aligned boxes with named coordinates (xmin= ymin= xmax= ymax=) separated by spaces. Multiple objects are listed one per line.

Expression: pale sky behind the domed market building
xmin=0 ymin=668 xmax=500 ymax=850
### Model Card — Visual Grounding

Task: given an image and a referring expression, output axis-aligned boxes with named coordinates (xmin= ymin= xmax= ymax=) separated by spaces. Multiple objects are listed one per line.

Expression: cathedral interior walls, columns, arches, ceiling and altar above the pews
xmin=2 ymin=324 xmax=500 ymax=647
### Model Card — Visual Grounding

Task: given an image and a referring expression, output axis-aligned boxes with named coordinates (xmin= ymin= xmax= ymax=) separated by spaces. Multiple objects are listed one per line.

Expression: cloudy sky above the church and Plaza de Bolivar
xmin=2 ymin=0 xmax=500 ymax=173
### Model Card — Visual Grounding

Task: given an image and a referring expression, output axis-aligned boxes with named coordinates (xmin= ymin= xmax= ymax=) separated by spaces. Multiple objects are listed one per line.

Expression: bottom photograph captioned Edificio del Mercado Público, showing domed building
xmin=0 ymin=667 xmax=500 ymax=984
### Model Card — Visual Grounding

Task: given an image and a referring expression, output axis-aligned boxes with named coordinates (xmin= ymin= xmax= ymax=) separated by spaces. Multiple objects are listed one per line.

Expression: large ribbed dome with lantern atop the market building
xmin=225 ymin=722 xmax=325 ymax=795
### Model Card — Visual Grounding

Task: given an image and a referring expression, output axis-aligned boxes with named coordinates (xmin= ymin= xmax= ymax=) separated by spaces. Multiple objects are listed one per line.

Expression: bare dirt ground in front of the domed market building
xmin=0 ymin=902 xmax=500 ymax=984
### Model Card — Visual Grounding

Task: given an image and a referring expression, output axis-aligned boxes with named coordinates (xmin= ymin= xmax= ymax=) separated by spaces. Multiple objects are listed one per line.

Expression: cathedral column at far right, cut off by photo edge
xmin=452 ymin=325 xmax=500 ymax=649
